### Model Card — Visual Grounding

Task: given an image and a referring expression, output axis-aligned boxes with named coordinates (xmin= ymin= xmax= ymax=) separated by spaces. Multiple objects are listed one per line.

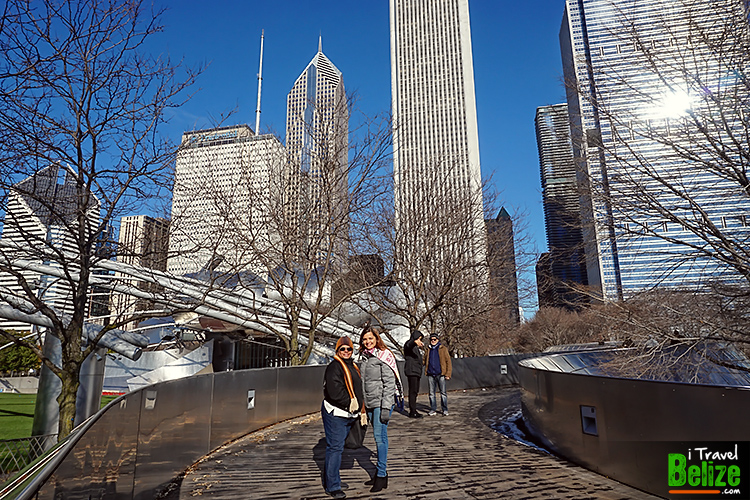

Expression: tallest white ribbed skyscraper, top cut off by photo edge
xmin=390 ymin=0 xmax=487 ymax=278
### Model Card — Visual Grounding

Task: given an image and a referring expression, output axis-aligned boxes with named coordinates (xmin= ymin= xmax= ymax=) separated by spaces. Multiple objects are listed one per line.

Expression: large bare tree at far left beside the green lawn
xmin=0 ymin=0 xmax=196 ymax=439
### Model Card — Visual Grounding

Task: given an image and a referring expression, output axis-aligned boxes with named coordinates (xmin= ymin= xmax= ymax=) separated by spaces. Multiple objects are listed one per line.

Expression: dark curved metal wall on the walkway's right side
xmin=519 ymin=363 xmax=750 ymax=496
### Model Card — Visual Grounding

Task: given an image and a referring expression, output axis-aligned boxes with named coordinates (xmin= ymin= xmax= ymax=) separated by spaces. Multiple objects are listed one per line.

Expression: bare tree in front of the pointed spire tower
xmin=256 ymin=96 xmax=391 ymax=364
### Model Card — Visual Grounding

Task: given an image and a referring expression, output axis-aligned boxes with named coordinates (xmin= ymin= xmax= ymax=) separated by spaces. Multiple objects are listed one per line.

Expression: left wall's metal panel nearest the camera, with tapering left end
xmin=38 ymin=393 xmax=141 ymax=500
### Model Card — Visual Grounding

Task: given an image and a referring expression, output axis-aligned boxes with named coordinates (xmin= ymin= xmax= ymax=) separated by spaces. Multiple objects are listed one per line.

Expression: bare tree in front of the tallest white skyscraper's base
xmin=350 ymin=160 xmax=525 ymax=355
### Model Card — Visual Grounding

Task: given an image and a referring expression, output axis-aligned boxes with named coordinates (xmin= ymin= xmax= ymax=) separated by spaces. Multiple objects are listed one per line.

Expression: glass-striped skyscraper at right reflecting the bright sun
xmin=560 ymin=0 xmax=750 ymax=300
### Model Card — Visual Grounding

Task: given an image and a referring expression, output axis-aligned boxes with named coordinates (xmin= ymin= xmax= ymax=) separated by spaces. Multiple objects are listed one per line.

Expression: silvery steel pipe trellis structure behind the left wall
xmin=0 ymin=240 xmax=368 ymax=445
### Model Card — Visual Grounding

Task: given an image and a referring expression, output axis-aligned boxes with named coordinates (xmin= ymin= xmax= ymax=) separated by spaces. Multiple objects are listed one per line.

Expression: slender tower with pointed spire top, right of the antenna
xmin=286 ymin=38 xmax=349 ymax=262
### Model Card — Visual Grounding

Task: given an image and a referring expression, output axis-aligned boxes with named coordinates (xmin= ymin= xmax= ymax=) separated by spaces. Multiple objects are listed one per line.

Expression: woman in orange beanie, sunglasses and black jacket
xmin=320 ymin=337 xmax=364 ymax=498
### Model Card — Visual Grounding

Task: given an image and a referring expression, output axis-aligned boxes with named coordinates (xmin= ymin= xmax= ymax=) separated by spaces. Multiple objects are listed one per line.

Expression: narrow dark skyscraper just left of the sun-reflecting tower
xmin=535 ymin=104 xmax=588 ymax=308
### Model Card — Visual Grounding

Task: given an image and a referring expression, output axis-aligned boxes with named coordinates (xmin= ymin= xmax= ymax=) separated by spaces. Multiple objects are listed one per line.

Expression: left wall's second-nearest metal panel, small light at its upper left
xmin=133 ymin=373 xmax=214 ymax=499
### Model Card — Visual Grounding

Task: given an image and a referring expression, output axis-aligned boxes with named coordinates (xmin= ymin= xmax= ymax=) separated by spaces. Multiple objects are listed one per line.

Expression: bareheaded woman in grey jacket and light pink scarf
xmin=359 ymin=326 xmax=401 ymax=492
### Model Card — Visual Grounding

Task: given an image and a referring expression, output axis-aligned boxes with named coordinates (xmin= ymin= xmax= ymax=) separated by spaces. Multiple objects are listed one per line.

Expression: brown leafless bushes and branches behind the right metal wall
xmin=512 ymin=288 xmax=750 ymax=383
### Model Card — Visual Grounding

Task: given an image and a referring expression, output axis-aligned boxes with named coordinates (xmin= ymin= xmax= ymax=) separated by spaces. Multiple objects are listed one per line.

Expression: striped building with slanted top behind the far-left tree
xmin=0 ymin=165 xmax=99 ymax=331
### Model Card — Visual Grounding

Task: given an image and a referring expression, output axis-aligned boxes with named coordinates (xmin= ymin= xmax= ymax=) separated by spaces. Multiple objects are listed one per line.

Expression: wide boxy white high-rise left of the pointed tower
xmin=167 ymin=125 xmax=285 ymax=275
